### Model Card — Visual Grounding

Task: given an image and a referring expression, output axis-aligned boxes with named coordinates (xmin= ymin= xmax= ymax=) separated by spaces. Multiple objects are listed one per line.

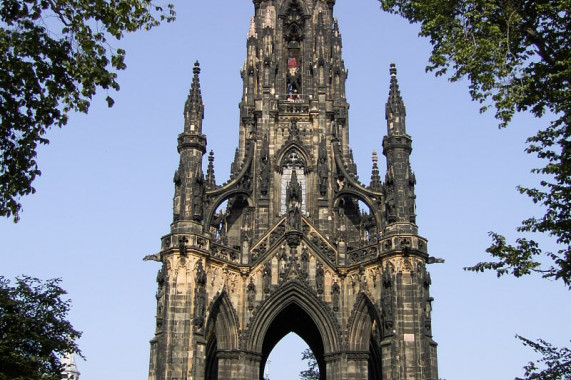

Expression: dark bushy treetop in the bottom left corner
xmin=0 ymin=276 xmax=81 ymax=380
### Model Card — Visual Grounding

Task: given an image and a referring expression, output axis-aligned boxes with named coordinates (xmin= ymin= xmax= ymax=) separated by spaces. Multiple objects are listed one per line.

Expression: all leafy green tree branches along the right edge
xmin=379 ymin=0 xmax=571 ymax=379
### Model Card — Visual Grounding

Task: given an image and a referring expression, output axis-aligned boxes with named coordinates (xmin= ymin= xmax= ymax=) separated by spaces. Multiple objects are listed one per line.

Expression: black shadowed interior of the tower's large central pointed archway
xmin=259 ymin=303 xmax=326 ymax=380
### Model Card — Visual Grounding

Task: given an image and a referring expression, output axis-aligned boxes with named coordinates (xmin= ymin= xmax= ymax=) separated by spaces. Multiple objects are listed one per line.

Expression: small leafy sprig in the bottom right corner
xmin=516 ymin=335 xmax=571 ymax=380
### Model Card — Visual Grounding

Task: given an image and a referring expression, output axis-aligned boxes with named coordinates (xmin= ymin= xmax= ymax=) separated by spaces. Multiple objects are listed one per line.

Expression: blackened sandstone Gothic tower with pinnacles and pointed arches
xmin=147 ymin=0 xmax=438 ymax=380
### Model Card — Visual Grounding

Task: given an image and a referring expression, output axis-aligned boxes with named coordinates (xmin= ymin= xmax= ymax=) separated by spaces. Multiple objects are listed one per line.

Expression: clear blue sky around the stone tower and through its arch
xmin=0 ymin=0 xmax=571 ymax=380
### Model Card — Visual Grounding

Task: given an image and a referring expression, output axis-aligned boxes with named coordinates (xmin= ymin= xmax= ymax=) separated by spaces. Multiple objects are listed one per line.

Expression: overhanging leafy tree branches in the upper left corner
xmin=0 ymin=0 xmax=175 ymax=222
